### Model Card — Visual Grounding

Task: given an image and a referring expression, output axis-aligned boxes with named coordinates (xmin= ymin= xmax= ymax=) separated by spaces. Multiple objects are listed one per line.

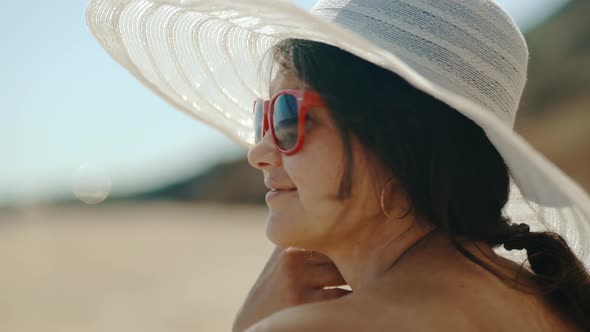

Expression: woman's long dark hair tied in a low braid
xmin=271 ymin=39 xmax=590 ymax=330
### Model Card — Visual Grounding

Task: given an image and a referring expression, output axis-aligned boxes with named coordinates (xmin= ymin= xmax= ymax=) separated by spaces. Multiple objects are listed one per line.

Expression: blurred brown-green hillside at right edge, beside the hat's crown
xmin=516 ymin=0 xmax=590 ymax=191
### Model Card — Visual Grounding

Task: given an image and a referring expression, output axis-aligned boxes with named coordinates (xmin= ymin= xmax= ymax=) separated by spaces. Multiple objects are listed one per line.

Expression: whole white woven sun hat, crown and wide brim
xmin=87 ymin=0 xmax=590 ymax=270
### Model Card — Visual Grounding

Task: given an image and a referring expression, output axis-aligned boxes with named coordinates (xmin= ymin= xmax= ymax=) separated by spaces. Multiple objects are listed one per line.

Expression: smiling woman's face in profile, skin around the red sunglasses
xmin=248 ymin=71 xmax=381 ymax=248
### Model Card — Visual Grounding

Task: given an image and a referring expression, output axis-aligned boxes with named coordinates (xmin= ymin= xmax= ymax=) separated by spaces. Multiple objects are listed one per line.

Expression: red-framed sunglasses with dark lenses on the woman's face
xmin=253 ymin=90 xmax=325 ymax=155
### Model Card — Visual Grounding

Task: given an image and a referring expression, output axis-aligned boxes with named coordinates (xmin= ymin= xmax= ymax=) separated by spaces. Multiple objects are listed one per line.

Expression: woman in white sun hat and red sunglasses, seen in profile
xmin=88 ymin=0 xmax=590 ymax=331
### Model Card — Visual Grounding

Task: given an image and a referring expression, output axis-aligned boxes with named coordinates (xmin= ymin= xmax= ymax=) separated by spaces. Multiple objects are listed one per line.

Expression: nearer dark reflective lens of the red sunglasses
xmin=272 ymin=94 xmax=299 ymax=150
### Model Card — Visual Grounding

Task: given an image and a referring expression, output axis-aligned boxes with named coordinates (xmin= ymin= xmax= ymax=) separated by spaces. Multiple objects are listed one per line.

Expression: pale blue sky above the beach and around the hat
xmin=0 ymin=0 xmax=567 ymax=205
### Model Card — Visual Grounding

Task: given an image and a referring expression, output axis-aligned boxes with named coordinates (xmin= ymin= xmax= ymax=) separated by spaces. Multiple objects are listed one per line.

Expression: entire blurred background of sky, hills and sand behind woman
xmin=0 ymin=0 xmax=590 ymax=332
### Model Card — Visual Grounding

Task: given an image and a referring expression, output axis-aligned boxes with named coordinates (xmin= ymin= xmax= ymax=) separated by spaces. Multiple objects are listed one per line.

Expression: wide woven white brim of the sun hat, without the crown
xmin=87 ymin=0 xmax=590 ymax=270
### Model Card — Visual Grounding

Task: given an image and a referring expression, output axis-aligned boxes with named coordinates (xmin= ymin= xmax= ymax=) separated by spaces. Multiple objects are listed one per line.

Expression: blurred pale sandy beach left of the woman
xmin=0 ymin=203 xmax=274 ymax=332
